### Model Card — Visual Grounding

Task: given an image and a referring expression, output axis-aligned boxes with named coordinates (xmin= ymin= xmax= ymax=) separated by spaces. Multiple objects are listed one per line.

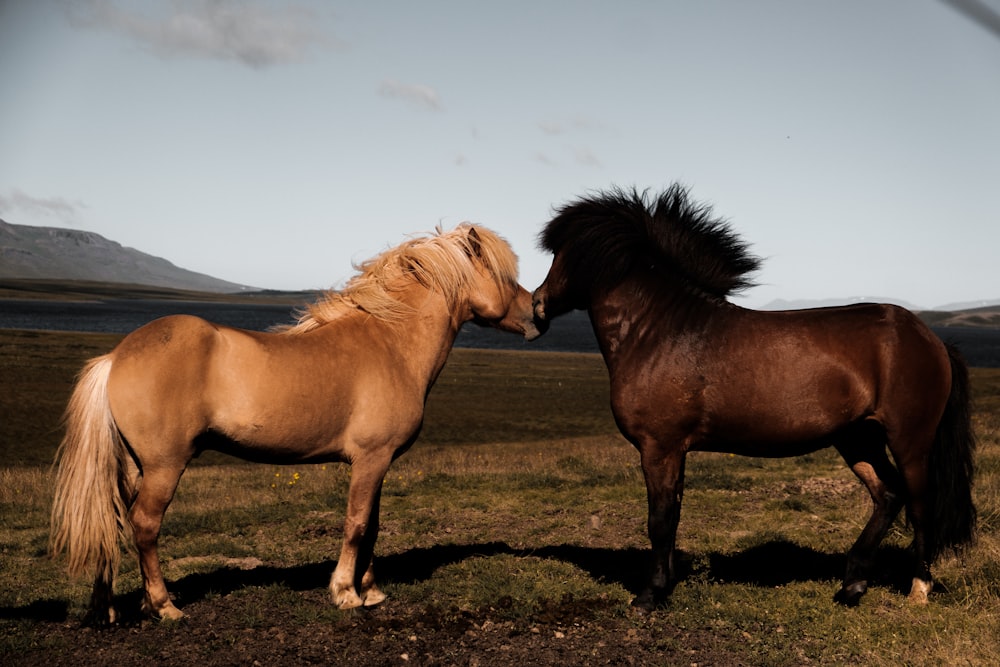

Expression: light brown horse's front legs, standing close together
xmin=330 ymin=452 xmax=392 ymax=609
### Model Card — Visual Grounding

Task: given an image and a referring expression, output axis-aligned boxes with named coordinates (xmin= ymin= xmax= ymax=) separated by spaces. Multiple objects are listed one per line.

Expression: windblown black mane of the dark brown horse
xmin=540 ymin=183 xmax=760 ymax=298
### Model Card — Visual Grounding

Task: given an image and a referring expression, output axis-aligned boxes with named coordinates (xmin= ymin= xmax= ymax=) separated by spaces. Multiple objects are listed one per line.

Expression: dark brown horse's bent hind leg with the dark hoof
xmin=834 ymin=439 xmax=904 ymax=607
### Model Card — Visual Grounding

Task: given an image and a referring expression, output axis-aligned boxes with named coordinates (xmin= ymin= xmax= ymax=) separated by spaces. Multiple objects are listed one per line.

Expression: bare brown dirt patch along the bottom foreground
xmin=2 ymin=590 xmax=746 ymax=667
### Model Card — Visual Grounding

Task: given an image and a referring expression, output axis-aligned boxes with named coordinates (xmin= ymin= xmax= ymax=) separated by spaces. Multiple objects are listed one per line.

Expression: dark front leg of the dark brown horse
xmin=632 ymin=444 xmax=684 ymax=612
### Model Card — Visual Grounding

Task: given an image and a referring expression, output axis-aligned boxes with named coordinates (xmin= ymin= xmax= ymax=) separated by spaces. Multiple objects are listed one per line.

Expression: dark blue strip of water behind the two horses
xmin=0 ymin=299 xmax=1000 ymax=368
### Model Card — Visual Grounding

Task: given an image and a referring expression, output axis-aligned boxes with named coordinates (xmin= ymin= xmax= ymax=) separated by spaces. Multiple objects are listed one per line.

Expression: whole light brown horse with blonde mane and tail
xmin=52 ymin=224 xmax=541 ymax=624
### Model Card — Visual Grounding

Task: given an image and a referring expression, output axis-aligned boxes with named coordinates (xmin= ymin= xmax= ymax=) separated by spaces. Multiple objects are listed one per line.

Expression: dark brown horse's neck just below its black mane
xmin=589 ymin=275 xmax=731 ymax=371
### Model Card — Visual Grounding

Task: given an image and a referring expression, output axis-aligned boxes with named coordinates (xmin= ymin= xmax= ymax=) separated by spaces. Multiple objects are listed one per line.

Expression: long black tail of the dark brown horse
xmin=928 ymin=345 xmax=976 ymax=561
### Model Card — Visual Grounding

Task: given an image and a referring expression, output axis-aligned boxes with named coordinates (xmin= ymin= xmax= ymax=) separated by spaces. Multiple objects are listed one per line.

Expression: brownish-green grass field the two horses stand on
xmin=0 ymin=331 xmax=1000 ymax=665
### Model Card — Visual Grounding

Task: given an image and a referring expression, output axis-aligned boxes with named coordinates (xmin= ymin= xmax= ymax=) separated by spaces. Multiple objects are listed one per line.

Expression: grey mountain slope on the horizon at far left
xmin=0 ymin=220 xmax=256 ymax=293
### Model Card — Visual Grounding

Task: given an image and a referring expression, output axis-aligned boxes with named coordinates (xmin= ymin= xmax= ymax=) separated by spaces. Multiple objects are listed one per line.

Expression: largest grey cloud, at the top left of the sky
xmin=65 ymin=0 xmax=330 ymax=69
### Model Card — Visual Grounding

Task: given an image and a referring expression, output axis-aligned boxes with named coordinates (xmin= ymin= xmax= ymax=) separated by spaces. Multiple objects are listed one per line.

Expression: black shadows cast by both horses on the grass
xmin=0 ymin=539 xmax=912 ymax=623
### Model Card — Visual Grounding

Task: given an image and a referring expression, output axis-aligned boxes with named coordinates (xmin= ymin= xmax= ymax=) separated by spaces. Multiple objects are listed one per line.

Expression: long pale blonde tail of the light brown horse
xmin=50 ymin=354 xmax=134 ymax=587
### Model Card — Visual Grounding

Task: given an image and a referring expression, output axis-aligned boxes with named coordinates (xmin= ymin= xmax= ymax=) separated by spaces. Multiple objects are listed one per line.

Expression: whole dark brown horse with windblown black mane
xmin=534 ymin=185 xmax=976 ymax=610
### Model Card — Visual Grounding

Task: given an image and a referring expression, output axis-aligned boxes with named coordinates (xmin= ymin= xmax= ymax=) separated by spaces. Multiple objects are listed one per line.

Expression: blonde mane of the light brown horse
xmin=280 ymin=223 xmax=517 ymax=334
